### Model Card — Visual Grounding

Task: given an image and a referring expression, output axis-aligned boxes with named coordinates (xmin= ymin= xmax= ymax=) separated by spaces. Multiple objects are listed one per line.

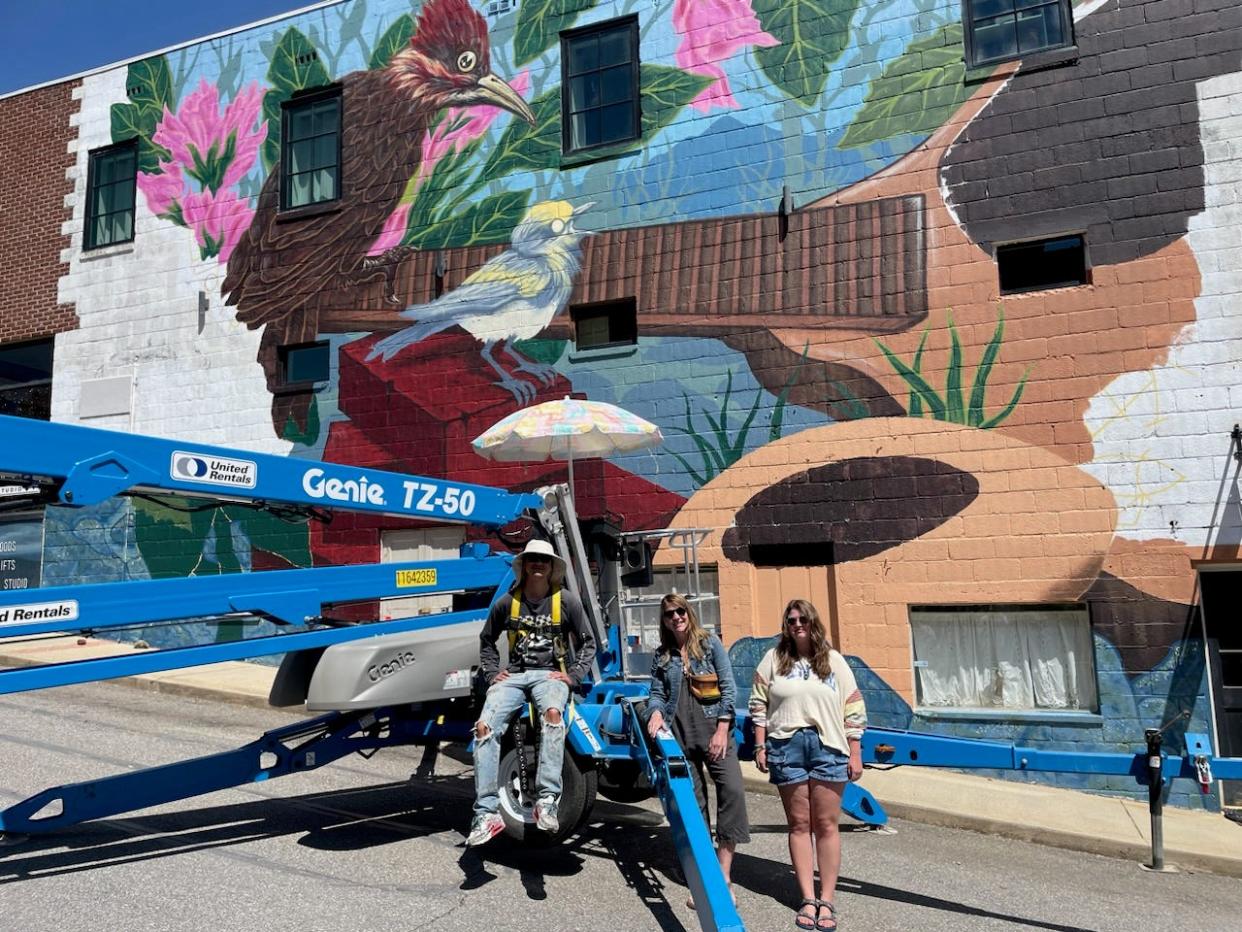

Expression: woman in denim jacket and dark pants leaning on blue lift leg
xmin=647 ymin=593 xmax=750 ymax=908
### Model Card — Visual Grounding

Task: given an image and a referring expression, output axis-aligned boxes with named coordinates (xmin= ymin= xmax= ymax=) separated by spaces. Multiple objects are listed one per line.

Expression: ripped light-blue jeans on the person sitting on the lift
xmin=474 ymin=670 xmax=569 ymax=815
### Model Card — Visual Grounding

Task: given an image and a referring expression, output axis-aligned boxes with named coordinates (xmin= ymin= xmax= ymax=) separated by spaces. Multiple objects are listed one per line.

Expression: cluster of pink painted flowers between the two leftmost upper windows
xmin=138 ymin=81 xmax=267 ymax=262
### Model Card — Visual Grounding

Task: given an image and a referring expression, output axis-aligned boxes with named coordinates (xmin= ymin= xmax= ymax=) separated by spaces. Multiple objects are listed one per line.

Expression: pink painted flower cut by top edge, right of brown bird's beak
xmin=673 ymin=0 xmax=780 ymax=113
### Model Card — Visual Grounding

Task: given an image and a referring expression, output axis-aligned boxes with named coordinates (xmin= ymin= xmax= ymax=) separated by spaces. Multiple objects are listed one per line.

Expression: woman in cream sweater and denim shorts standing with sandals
xmin=750 ymin=599 xmax=867 ymax=932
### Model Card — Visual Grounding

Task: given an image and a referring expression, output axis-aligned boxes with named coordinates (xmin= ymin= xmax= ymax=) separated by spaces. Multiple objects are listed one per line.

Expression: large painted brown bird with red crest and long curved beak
xmin=222 ymin=0 xmax=534 ymax=435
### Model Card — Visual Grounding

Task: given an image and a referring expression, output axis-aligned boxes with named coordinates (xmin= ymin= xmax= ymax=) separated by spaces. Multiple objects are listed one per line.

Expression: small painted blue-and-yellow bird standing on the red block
xmin=368 ymin=200 xmax=592 ymax=404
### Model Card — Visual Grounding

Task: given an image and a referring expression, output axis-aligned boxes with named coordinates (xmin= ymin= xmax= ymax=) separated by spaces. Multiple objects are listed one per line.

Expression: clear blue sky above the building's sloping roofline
xmin=0 ymin=0 xmax=314 ymax=94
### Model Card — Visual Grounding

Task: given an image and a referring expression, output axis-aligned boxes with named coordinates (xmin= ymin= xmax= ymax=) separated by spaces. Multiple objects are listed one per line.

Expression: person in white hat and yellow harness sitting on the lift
xmin=466 ymin=541 xmax=595 ymax=846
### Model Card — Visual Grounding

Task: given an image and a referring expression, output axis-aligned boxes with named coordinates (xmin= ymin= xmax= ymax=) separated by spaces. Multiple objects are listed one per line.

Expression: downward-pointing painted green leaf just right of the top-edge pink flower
xmin=754 ymin=0 xmax=861 ymax=107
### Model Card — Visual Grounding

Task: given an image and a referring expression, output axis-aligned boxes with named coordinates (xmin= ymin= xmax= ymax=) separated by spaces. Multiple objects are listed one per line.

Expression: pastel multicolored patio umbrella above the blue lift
xmin=472 ymin=398 xmax=664 ymax=491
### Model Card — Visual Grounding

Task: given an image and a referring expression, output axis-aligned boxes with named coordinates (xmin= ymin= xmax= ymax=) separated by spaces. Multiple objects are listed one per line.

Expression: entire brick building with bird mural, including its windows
xmin=0 ymin=0 xmax=1242 ymax=808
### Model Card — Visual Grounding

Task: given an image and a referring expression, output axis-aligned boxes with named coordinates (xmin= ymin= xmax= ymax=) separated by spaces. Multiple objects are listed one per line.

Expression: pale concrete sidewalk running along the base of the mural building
xmin=0 ymin=637 xmax=1242 ymax=877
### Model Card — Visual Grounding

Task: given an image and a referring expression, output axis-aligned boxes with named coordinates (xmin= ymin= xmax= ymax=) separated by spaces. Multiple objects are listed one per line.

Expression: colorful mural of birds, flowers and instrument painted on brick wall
xmin=43 ymin=0 xmax=1242 ymax=805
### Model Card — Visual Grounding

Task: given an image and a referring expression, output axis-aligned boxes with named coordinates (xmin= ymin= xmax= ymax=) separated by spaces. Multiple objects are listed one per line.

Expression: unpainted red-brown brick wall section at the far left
xmin=0 ymin=82 xmax=78 ymax=343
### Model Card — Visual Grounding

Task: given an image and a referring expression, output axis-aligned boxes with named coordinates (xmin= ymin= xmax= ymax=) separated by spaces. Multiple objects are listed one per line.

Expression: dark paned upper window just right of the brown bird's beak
xmin=560 ymin=16 xmax=641 ymax=153
